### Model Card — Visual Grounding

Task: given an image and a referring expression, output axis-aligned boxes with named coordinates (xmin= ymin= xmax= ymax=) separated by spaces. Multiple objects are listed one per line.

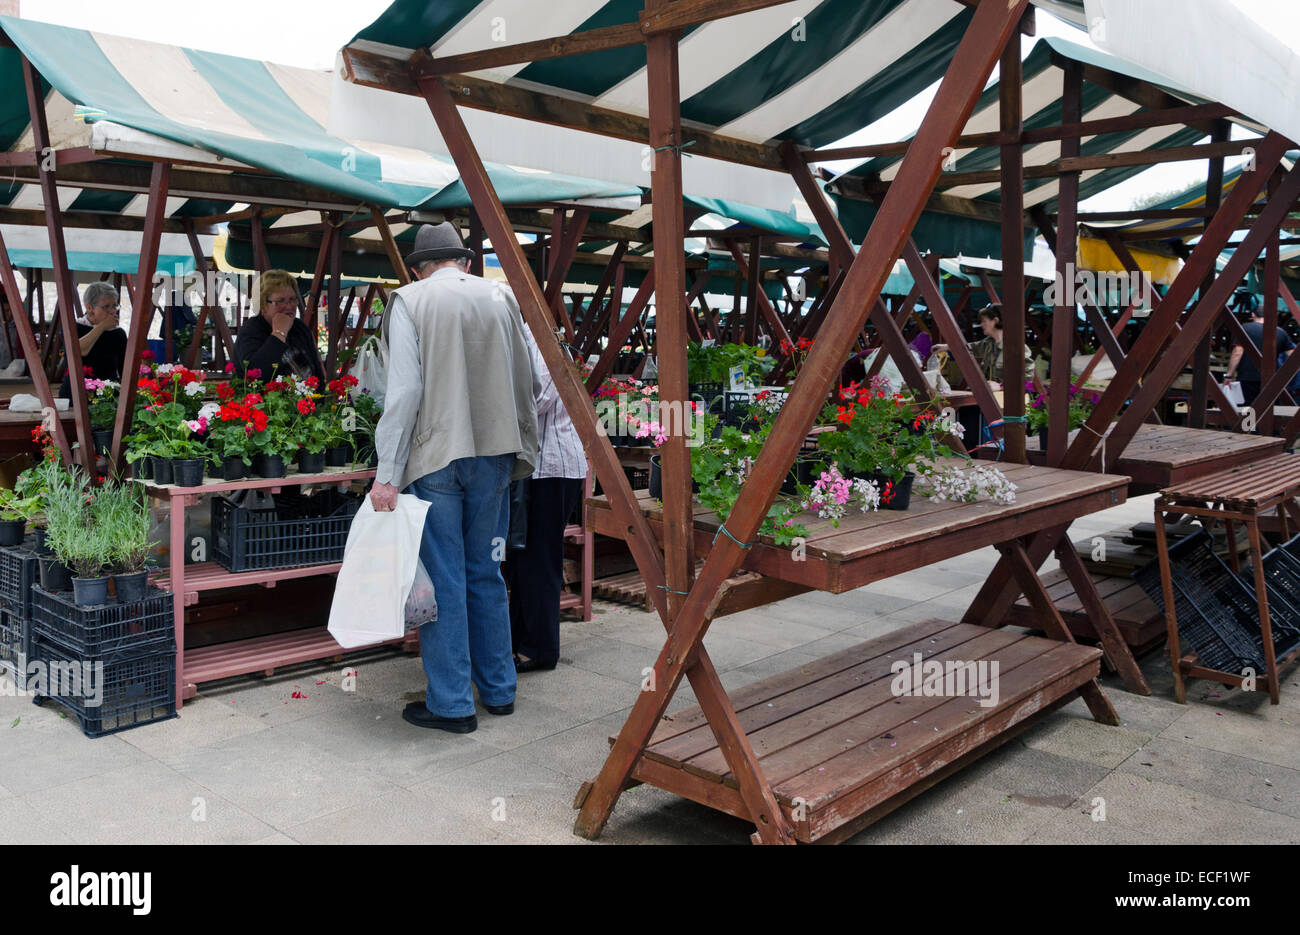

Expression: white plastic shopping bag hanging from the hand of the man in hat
xmin=329 ymin=494 xmax=437 ymax=649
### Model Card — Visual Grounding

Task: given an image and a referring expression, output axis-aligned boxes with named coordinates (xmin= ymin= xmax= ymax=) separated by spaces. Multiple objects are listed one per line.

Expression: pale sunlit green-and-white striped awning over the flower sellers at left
xmin=0 ymin=17 xmax=640 ymax=213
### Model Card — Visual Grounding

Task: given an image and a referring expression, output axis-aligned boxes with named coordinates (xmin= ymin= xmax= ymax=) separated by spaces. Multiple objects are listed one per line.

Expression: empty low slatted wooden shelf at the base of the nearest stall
xmin=634 ymin=620 xmax=1101 ymax=841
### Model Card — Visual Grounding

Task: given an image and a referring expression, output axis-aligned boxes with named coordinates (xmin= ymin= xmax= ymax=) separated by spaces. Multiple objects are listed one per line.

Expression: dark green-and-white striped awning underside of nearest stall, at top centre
xmin=350 ymin=0 xmax=972 ymax=146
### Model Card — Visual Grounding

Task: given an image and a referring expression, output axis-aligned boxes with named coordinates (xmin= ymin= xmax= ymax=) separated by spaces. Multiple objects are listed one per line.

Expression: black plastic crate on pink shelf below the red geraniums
xmin=212 ymin=488 xmax=361 ymax=572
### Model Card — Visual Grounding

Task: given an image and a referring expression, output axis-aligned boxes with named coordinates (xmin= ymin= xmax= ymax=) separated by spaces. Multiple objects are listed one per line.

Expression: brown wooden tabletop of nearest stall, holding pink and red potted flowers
xmin=588 ymin=464 xmax=1128 ymax=592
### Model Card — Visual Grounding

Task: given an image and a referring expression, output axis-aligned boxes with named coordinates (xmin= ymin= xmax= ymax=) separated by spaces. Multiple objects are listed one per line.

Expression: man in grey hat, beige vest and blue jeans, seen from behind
xmin=371 ymin=221 xmax=541 ymax=733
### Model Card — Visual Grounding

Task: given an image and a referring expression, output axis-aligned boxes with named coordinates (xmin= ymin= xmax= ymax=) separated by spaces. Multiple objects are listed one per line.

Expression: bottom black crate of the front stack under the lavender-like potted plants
xmin=33 ymin=636 xmax=176 ymax=737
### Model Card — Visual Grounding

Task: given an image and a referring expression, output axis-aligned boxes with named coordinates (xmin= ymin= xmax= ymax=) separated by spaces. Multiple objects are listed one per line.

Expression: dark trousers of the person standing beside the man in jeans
xmin=506 ymin=477 xmax=582 ymax=666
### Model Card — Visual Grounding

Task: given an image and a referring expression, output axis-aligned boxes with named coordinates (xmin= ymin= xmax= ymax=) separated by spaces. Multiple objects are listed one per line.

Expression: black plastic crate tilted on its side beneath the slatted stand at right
xmin=1134 ymin=531 xmax=1265 ymax=672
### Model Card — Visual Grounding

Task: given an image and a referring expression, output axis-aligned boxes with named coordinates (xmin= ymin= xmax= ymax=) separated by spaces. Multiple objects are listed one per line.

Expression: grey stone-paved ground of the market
xmin=0 ymin=498 xmax=1300 ymax=844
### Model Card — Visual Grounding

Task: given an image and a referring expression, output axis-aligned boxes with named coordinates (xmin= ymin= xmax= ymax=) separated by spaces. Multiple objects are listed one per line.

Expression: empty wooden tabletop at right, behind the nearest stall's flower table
xmin=1026 ymin=424 xmax=1286 ymax=489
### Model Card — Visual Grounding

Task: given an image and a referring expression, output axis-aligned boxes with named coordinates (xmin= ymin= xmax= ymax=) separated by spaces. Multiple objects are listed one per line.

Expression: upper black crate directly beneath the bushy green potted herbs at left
xmin=31 ymin=586 xmax=176 ymax=658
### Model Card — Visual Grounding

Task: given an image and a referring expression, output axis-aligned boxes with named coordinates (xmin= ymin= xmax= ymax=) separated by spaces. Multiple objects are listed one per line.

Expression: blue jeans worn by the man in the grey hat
xmin=407 ymin=454 xmax=515 ymax=718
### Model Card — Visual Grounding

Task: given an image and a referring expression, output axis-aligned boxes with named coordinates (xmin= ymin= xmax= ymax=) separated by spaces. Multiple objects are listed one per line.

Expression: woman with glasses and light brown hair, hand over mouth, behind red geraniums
xmin=235 ymin=269 xmax=325 ymax=385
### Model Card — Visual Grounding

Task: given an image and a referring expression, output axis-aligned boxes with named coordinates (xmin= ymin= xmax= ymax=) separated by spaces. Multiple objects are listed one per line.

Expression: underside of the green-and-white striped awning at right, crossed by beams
xmin=832 ymin=38 xmax=1261 ymax=221
